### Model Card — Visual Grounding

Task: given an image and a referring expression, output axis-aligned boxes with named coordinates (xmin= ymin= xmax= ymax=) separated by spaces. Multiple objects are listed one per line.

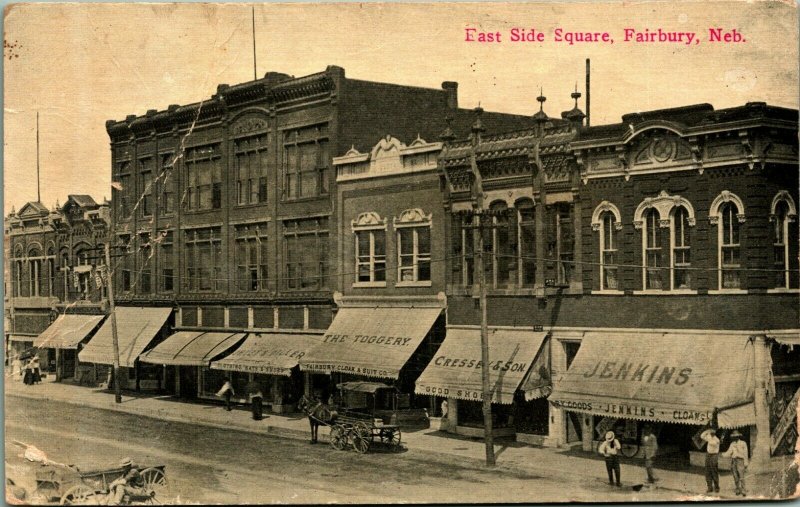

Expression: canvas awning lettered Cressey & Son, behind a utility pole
xmin=415 ymin=328 xmax=547 ymax=404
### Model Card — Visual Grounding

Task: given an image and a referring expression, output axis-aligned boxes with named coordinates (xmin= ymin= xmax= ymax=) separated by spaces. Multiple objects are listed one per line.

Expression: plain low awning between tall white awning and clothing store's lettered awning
xmin=139 ymin=331 xmax=245 ymax=366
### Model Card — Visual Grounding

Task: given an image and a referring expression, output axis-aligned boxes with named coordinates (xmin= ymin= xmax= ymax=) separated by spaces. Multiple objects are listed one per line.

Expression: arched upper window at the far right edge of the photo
xmin=770 ymin=190 xmax=798 ymax=289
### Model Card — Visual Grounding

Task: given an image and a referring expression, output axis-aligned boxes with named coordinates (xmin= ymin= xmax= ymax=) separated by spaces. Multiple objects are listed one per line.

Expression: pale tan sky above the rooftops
xmin=3 ymin=2 xmax=798 ymax=213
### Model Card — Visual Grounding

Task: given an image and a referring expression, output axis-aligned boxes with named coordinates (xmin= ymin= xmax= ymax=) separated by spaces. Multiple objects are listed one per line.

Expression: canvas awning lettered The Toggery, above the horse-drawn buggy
xmin=300 ymin=306 xmax=442 ymax=379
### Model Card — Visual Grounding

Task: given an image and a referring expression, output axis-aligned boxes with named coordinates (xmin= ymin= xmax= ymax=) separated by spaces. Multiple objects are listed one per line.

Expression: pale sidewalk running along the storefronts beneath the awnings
xmin=5 ymin=377 xmax=790 ymax=500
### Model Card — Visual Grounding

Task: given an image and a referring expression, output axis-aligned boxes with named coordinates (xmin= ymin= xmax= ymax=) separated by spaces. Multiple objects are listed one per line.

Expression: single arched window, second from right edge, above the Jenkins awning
xmin=709 ymin=190 xmax=745 ymax=290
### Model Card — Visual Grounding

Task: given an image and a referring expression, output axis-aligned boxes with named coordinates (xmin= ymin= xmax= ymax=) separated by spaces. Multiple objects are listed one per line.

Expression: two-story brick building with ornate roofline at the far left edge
xmin=5 ymin=195 xmax=109 ymax=379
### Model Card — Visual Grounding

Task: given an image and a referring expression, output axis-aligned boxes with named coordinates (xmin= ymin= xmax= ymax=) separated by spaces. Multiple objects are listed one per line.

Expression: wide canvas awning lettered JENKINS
xmin=549 ymin=333 xmax=755 ymax=428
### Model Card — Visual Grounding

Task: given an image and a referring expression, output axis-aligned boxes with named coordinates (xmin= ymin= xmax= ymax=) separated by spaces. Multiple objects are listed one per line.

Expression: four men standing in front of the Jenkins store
xmin=597 ymin=425 xmax=749 ymax=496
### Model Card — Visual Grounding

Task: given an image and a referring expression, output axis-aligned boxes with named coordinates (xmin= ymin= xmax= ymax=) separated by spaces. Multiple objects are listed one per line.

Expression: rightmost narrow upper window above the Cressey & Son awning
xmin=545 ymin=202 xmax=575 ymax=286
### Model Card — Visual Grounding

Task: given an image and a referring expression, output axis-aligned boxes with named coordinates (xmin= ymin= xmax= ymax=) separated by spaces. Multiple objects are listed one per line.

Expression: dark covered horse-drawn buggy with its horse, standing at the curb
xmin=299 ymin=382 xmax=402 ymax=454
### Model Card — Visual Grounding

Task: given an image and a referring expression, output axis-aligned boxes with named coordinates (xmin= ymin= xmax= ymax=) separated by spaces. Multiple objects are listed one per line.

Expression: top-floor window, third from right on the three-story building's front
xmin=184 ymin=144 xmax=222 ymax=210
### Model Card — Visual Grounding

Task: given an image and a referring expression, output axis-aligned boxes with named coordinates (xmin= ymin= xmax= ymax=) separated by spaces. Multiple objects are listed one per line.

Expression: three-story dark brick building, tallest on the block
xmin=101 ymin=66 xmax=527 ymax=404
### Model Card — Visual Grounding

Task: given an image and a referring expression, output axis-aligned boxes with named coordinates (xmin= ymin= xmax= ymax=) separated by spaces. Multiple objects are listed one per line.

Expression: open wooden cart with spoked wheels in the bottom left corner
xmin=36 ymin=463 xmax=169 ymax=505
